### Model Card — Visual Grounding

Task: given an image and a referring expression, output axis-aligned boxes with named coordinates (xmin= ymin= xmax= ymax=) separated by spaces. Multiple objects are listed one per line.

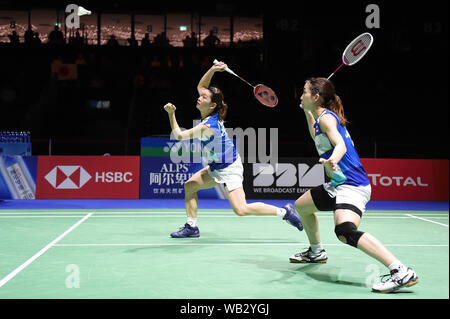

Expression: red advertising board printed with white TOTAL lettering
xmin=361 ymin=158 xmax=449 ymax=201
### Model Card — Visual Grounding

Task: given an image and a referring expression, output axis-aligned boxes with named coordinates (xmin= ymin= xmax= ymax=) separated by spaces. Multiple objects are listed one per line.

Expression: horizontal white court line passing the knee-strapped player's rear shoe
xmin=55 ymin=244 xmax=448 ymax=247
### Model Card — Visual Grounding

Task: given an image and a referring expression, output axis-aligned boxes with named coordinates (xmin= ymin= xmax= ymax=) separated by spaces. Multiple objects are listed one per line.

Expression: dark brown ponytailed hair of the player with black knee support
xmin=307 ymin=78 xmax=348 ymax=126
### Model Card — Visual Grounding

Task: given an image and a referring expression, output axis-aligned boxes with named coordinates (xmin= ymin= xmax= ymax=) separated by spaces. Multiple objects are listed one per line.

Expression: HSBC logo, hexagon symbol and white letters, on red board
xmin=45 ymin=165 xmax=133 ymax=189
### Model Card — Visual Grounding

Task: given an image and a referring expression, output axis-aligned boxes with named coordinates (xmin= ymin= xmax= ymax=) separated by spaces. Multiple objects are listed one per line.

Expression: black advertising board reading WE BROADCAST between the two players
xmin=244 ymin=157 xmax=328 ymax=199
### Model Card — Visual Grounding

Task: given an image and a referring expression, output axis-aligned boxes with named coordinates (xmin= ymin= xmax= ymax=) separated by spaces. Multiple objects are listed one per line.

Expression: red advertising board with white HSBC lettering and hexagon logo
xmin=36 ymin=156 xmax=140 ymax=199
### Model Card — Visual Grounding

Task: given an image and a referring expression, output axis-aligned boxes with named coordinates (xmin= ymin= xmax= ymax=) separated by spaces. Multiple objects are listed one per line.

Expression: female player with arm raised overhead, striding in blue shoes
xmin=164 ymin=62 xmax=303 ymax=238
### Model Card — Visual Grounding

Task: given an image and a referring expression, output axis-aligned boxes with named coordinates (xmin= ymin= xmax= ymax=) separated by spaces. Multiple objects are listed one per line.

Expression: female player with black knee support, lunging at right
xmin=290 ymin=78 xmax=418 ymax=292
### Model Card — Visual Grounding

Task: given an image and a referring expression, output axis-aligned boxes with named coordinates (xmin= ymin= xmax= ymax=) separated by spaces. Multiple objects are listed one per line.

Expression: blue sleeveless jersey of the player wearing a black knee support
xmin=314 ymin=110 xmax=370 ymax=187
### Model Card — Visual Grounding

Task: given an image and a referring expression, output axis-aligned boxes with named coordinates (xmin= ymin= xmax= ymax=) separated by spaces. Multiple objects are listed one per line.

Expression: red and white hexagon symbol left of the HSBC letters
xmin=45 ymin=165 xmax=92 ymax=189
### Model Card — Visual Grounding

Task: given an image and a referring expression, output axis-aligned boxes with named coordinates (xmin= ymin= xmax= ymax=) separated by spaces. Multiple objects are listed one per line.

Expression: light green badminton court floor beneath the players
xmin=0 ymin=209 xmax=449 ymax=299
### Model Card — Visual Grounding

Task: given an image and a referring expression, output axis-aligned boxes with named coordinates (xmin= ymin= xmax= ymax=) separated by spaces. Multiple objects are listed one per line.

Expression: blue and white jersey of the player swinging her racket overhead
xmin=200 ymin=113 xmax=238 ymax=171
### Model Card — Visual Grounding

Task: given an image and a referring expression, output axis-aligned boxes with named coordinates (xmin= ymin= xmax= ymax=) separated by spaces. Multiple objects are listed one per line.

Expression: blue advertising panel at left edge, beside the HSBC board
xmin=0 ymin=155 xmax=37 ymax=199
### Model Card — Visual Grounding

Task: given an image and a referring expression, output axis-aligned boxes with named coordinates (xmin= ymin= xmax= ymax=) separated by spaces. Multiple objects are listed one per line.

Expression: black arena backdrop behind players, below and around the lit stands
xmin=0 ymin=0 xmax=449 ymax=158
